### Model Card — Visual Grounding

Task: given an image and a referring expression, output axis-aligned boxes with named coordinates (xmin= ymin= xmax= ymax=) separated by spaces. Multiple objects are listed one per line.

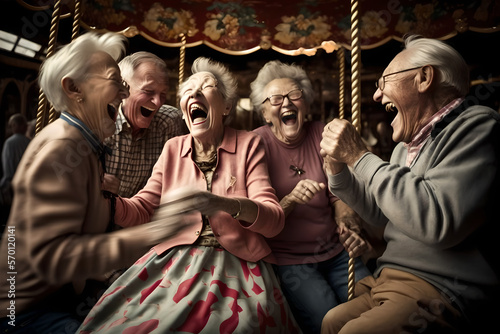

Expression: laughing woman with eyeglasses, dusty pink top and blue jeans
xmin=250 ymin=61 xmax=369 ymax=333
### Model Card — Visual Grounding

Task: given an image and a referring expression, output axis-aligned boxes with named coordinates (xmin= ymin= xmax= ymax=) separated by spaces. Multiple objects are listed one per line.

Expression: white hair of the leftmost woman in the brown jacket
xmin=38 ymin=32 xmax=127 ymax=111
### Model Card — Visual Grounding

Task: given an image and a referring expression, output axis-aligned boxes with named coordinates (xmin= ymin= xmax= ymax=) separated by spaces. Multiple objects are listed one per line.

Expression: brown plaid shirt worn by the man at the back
xmin=104 ymin=105 xmax=187 ymax=198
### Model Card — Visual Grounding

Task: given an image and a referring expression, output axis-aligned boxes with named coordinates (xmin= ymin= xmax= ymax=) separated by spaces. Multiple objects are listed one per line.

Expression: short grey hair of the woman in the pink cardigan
xmin=178 ymin=57 xmax=238 ymax=111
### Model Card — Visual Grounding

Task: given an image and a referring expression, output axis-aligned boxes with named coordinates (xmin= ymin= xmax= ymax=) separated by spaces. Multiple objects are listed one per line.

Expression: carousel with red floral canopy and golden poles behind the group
xmin=0 ymin=0 xmax=500 ymax=296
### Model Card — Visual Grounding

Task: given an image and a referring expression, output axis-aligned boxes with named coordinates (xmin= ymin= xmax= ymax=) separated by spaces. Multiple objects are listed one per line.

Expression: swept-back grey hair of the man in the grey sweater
xmin=404 ymin=35 xmax=470 ymax=96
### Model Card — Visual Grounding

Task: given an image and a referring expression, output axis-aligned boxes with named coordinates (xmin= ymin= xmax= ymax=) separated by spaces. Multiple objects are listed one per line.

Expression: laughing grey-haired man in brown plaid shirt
xmin=104 ymin=52 xmax=187 ymax=197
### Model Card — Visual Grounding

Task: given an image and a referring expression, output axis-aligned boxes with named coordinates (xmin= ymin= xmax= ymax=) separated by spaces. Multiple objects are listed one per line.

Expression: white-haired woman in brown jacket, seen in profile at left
xmin=0 ymin=33 xmax=195 ymax=333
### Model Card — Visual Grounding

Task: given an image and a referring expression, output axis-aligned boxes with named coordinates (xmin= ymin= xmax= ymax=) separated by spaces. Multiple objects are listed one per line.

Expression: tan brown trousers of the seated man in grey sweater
xmin=321 ymin=268 xmax=463 ymax=334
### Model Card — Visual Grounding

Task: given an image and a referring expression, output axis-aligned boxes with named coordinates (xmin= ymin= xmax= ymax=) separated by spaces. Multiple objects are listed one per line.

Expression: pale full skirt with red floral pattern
xmin=77 ymin=245 xmax=300 ymax=334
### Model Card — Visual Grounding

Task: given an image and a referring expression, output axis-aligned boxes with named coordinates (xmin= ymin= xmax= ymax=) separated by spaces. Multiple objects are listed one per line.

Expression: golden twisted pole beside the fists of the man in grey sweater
xmin=347 ymin=0 xmax=361 ymax=300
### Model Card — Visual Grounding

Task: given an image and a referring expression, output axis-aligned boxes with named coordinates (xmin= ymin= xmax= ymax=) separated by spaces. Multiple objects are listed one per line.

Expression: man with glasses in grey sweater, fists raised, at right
xmin=321 ymin=36 xmax=500 ymax=334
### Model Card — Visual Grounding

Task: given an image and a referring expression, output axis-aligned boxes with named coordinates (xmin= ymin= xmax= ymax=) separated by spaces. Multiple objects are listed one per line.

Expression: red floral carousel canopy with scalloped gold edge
xmin=18 ymin=0 xmax=500 ymax=55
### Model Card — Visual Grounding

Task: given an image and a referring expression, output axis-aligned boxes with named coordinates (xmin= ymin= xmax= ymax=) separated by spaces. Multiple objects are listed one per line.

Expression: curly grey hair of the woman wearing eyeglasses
xmin=250 ymin=60 xmax=314 ymax=112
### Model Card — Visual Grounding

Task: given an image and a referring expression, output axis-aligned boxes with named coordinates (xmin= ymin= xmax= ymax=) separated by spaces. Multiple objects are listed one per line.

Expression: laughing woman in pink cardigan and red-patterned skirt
xmin=78 ymin=58 xmax=299 ymax=334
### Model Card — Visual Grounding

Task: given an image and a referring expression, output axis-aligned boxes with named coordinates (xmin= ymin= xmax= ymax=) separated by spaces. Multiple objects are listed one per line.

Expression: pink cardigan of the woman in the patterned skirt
xmin=115 ymin=128 xmax=285 ymax=263
